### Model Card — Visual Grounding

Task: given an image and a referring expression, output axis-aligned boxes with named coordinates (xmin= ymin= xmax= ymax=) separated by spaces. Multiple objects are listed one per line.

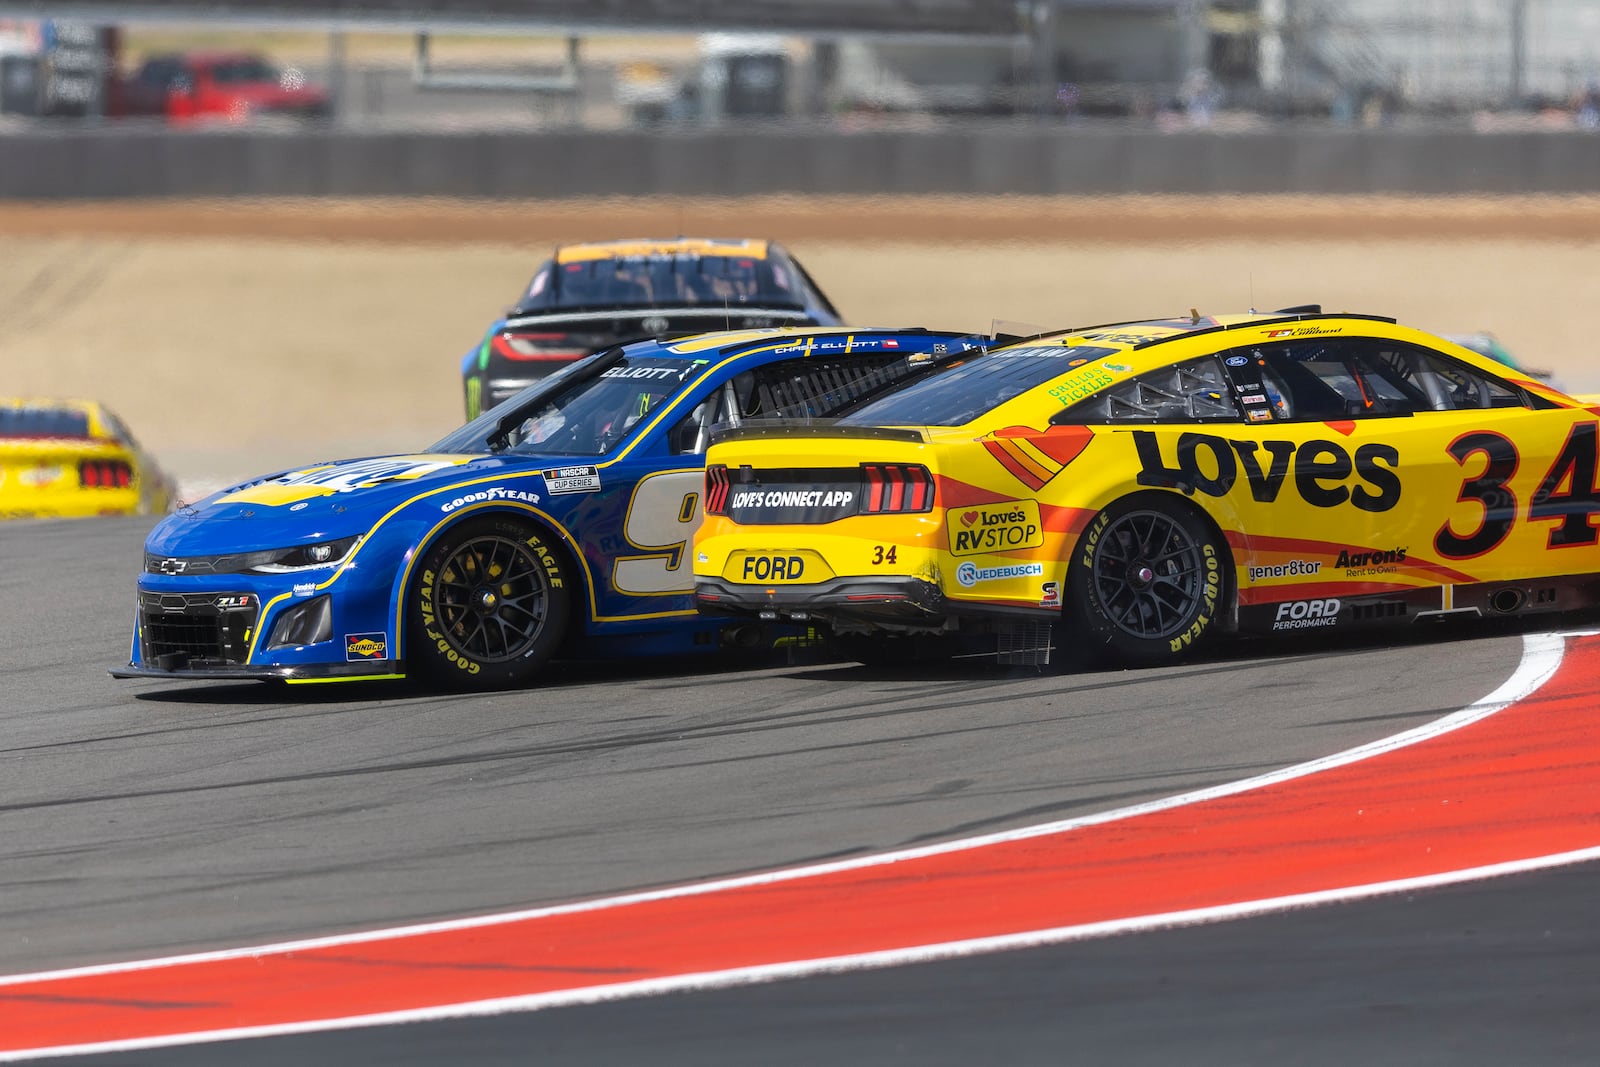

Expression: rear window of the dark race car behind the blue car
xmin=517 ymin=253 xmax=803 ymax=312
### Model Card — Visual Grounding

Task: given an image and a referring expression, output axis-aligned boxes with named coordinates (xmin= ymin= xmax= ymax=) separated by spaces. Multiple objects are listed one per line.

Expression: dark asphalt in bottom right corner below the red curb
xmin=106 ymin=864 xmax=1600 ymax=1067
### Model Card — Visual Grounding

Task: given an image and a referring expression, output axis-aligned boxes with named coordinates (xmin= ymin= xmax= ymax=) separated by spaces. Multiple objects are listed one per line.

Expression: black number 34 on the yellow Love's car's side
xmin=1434 ymin=422 xmax=1600 ymax=560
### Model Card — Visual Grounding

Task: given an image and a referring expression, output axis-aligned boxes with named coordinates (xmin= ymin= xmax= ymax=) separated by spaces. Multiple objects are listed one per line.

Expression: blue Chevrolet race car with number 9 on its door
xmin=112 ymin=330 xmax=984 ymax=688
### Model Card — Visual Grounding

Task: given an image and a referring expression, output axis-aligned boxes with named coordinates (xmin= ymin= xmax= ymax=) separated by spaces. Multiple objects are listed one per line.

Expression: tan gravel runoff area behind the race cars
xmin=0 ymin=197 xmax=1600 ymax=486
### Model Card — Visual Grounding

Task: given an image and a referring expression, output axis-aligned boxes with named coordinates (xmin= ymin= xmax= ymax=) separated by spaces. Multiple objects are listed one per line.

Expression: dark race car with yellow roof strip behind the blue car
xmin=461 ymin=237 xmax=842 ymax=419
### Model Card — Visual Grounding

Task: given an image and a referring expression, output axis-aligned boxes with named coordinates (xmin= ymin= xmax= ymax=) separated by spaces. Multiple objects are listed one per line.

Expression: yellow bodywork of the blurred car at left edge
xmin=0 ymin=398 xmax=176 ymax=518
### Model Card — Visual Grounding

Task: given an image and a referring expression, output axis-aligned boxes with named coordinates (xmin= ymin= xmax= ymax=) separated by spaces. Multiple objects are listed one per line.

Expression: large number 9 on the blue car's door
xmin=611 ymin=470 xmax=706 ymax=597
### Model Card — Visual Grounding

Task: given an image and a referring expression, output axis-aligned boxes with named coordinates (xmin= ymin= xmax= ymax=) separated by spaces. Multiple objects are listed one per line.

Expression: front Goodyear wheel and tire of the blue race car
xmin=408 ymin=517 xmax=573 ymax=689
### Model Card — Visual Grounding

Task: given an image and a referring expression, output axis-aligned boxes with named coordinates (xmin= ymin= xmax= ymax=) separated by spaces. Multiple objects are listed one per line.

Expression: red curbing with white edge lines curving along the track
xmin=0 ymin=632 xmax=1600 ymax=1062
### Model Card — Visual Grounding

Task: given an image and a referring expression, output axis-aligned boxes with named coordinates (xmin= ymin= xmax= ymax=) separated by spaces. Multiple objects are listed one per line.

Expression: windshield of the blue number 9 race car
xmin=430 ymin=350 xmax=702 ymax=456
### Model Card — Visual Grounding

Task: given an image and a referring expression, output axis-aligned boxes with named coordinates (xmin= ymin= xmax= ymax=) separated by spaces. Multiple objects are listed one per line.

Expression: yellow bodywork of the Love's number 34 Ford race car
xmin=694 ymin=315 xmax=1600 ymax=620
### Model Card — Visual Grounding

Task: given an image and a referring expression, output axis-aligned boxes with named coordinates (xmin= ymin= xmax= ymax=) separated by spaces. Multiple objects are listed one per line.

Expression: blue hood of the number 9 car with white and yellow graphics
xmin=146 ymin=454 xmax=553 ymax=557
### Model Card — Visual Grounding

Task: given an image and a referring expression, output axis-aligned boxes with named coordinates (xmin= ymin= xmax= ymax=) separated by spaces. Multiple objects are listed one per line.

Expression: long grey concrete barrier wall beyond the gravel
xmin=9 ymin=125 xmax=1600 ymax=200
